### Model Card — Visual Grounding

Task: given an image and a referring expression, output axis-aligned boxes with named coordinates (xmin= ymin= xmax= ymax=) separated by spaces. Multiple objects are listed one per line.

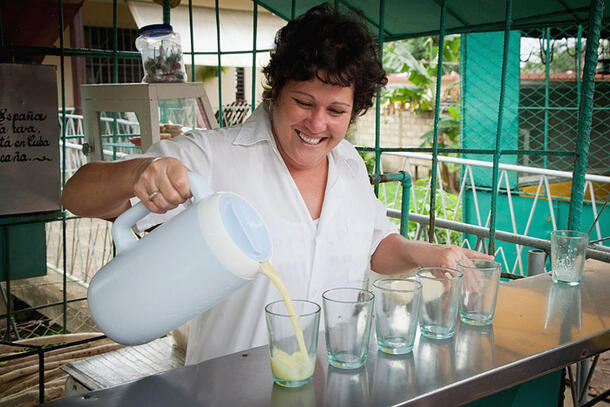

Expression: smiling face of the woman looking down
xmin=272 ymin=78 xmax=354 ymax=170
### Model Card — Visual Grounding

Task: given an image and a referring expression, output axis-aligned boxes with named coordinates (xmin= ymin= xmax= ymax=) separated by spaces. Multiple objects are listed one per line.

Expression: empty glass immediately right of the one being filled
xmin=322 ymin=288 xmax=375 ymax=369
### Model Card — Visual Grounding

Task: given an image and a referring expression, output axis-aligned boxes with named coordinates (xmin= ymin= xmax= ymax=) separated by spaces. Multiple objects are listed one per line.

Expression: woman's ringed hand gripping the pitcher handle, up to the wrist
xmin=133 ymin=157 xmax=192 ymax=213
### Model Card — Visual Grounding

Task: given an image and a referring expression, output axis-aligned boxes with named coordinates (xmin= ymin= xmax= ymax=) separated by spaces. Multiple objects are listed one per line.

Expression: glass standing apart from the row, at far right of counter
xmin=551 ymin=230 xmax=588 ymax=285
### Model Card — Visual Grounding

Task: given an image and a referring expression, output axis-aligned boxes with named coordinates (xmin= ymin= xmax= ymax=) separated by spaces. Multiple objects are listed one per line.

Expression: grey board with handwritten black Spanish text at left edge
xmin=0 ymin=64 xmax=60 ymax=216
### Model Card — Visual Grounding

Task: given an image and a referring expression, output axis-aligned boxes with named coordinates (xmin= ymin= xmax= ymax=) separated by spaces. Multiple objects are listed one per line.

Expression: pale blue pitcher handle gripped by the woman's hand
xmin=112 ymin=172 xmax=214 ymax=253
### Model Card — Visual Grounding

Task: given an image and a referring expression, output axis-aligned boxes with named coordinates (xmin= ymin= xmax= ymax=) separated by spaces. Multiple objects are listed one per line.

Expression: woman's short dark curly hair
xmin=263 ymin=3 xmax=388 ymax=121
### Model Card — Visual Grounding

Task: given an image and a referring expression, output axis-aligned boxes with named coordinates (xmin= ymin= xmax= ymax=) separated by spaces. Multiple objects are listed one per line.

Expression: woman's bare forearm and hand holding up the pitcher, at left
xmin=61 ymin=157 xmax=191 ymax=219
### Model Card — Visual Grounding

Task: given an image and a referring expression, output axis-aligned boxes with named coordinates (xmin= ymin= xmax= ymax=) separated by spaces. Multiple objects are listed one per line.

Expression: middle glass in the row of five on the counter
xmin=373 ymin=277 xmax=422 ymax=355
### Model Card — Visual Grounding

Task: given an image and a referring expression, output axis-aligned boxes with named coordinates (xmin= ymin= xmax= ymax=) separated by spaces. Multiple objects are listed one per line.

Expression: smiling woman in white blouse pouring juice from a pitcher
xmin=62 ymin=4 xmax=489 ymax=364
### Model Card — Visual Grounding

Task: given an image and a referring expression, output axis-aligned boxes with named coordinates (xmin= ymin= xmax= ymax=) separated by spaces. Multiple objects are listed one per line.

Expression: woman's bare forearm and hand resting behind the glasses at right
xmin=371 ymin=233 xmax=493 ymax=274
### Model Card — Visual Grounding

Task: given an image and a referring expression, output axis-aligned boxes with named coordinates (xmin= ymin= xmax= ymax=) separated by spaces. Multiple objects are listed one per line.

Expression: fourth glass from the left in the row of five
xmin=415 ymin=267 xmax=462 ymax=339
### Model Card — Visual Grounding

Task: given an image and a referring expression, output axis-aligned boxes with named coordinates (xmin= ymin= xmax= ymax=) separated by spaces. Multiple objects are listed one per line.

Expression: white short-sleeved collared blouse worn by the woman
xmin=133 ymin=106 xmax=397 ymax=364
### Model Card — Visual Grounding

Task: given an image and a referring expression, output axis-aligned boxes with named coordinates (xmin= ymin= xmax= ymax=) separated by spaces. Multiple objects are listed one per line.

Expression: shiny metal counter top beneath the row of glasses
xmin=49 ymin=270 xmax=610 ymax=406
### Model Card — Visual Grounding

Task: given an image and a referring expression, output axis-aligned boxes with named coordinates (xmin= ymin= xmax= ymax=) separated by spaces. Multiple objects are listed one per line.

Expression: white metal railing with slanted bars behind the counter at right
xmin=381 ymin=152 xmax=610 ymax=275
